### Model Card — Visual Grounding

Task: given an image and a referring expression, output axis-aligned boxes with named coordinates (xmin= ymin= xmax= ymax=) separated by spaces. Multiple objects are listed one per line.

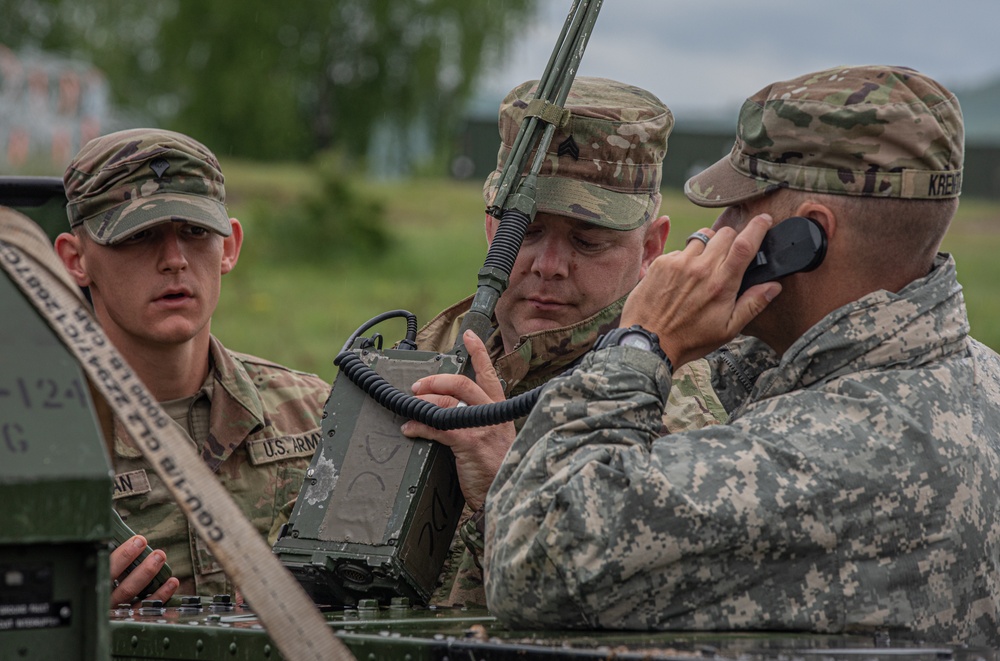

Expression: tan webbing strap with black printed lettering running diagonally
xmin=0 ymin=232 xmax=354 ymax=661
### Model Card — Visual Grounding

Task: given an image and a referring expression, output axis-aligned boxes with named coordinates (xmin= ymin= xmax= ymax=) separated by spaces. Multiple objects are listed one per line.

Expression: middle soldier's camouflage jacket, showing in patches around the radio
xmin=417 ymin=297 xmax=728 ymax=606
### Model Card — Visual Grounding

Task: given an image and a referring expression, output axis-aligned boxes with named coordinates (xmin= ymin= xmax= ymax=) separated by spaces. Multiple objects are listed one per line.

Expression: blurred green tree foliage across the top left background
xmin=0 ymin=0 xmax=541 ymax=161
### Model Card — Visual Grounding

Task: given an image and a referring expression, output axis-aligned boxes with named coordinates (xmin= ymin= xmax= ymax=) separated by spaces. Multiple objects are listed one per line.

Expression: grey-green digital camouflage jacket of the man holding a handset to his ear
xmin=486 ymin=255 xmax=1000 ymax=646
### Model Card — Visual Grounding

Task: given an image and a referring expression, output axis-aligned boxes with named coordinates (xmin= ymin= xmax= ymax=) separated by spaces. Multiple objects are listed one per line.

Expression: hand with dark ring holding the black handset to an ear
xmin=621 ymin=214 xmax=781 ymax=368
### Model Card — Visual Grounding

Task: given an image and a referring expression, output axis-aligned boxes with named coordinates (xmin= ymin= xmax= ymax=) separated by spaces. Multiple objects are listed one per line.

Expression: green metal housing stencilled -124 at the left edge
xmin=0 ymin=262 xmax=111 ymax=661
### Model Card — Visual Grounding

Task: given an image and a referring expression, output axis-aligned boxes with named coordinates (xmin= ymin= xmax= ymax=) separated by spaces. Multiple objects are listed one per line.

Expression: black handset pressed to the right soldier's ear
xmin=737 ymin=216 xmax=826 ymax=296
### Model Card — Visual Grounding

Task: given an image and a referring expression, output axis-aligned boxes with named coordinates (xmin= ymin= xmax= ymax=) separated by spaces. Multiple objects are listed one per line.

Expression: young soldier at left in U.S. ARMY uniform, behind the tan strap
xmin=56 ymin=129 xmax=330 ymax=603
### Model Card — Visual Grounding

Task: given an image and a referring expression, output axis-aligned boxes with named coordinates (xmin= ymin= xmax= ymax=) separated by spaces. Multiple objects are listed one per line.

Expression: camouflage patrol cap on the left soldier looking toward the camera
xmin=63 ymin=129 xmax=232 ymax=245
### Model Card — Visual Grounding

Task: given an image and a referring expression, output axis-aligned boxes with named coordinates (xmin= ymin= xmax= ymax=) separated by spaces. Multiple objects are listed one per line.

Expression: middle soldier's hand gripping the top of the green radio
xmin=401 ymin=331 xmax=517 ymax=510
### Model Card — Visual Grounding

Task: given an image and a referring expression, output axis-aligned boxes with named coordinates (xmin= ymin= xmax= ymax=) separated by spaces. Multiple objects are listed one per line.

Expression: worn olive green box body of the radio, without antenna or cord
xmin=274 ymin=349 xmax=465 ymax=607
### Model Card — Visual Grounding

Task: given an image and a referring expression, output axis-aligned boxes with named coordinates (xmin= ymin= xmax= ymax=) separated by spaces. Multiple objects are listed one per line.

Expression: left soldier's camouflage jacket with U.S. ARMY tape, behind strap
xmin=114 ymin=337 xmax=330 ymax=596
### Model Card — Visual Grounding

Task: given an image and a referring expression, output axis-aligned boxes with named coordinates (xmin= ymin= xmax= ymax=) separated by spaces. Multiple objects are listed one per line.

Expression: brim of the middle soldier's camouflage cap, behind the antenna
xmin=483 ymin=170 xmax=660 ymax=231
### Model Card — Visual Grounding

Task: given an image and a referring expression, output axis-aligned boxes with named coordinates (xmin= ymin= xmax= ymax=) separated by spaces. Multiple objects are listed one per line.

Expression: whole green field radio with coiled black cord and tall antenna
xmin=274 ymin=0 xmax=602 ymax=606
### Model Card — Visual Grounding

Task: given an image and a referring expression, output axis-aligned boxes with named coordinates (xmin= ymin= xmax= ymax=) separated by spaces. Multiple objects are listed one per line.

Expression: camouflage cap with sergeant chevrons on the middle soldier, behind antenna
xmin=483 ymin=78 xmax=674 ymax=230
